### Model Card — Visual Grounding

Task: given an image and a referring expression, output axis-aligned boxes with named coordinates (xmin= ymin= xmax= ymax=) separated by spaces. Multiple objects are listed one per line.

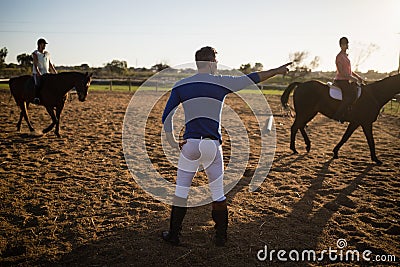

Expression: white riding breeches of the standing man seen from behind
xmin=175 ymin=139 xmax=226 ymax=201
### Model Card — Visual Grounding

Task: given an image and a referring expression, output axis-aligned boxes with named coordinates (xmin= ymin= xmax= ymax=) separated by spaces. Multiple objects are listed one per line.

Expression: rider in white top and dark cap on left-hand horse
xmin=32 ymin=38 xmax=57 ymax=104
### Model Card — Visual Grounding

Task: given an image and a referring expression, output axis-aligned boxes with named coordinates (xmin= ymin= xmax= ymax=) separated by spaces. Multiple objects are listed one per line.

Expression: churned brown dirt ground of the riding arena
xmin=0 ymin=90 xmax=400 ymax=266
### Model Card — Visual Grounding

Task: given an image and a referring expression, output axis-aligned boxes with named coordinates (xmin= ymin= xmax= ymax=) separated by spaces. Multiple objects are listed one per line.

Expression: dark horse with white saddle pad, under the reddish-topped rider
xmin=281 ymin=74 xmax=400 ymax=164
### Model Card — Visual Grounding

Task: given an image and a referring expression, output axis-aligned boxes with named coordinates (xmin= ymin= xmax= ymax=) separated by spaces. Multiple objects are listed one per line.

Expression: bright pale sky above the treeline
xmin=0 ymin=0 xmax=400 ymax=72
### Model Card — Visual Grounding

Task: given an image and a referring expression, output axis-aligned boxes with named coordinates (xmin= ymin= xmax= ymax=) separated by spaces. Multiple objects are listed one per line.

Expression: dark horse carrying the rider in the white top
xmin=9 ymin=72 xmax=92 ymax=137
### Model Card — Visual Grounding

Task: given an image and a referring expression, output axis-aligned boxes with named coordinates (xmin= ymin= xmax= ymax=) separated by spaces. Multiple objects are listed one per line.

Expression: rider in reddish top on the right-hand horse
xmin=333 ymin=37 xmax=363 ymax=122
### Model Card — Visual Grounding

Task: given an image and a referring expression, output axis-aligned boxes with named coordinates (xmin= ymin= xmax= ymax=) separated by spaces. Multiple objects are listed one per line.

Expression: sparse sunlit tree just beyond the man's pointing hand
xmin=287 ymin=51 xmax=319 ymax=80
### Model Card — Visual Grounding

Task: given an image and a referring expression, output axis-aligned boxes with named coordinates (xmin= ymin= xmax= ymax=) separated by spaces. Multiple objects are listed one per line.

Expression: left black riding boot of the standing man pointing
xmin=162 ymin=197 xmax=187 ymax=246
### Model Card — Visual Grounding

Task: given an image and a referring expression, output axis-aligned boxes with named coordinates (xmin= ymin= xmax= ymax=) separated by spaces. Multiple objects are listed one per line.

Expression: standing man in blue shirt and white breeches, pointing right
xmin=162 ymin=46 xmax=291 ymax=246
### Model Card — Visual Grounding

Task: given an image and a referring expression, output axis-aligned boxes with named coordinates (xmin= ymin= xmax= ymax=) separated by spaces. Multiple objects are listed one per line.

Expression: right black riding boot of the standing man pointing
xmin=212 ymin=200 xmax=228 ymax=247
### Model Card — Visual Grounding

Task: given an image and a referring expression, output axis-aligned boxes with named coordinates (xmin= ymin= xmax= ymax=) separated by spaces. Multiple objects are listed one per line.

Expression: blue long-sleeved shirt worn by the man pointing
xmin=162 ymin=73 xmax=260 ymax=142
